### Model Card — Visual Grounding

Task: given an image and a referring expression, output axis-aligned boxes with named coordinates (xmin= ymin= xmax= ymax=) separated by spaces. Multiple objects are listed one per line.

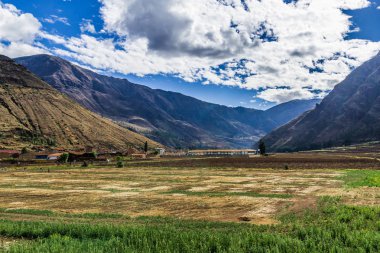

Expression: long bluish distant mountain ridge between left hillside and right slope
xmin=16 ymin=55 xmax=314 ymax=147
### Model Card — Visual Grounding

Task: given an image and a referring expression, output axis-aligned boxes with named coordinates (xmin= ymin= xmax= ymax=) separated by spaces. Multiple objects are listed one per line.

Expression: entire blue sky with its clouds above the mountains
xmin=0 ymin=0 xmax=380 ymax=109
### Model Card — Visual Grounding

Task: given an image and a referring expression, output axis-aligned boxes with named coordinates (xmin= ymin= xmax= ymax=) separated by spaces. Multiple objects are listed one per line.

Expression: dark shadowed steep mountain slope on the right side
xmin=264 ymin=53 xmax=380 ymax=151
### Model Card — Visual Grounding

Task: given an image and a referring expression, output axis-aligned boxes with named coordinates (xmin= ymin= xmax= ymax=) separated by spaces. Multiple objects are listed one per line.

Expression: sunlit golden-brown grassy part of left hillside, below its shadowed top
xmin=0 ymin=86 xmax=159 ymax=149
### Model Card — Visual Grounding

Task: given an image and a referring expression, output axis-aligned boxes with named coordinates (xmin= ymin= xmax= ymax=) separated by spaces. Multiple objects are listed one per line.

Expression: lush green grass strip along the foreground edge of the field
xmin=0 ymin=197 xmax=380 ymax=253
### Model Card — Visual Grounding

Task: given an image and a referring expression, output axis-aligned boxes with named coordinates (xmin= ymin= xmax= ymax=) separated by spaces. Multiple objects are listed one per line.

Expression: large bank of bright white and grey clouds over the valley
xmin=0 ymin=0 xmax=380 ymax=102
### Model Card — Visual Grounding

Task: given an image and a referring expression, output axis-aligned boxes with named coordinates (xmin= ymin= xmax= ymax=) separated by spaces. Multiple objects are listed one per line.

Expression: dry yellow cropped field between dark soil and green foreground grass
xmin=0 ymin=166 xmax=374 ymax=224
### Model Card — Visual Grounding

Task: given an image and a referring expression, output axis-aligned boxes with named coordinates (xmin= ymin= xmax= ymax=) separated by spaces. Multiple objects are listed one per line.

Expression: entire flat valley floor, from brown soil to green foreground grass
xmin=0 ymin=150 xmax=380 ymax=252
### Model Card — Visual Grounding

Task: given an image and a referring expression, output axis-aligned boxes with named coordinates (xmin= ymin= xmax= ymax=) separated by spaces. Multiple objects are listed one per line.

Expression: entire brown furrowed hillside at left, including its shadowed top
xmin=0 ymin=56 xmax=158 ymax=149
